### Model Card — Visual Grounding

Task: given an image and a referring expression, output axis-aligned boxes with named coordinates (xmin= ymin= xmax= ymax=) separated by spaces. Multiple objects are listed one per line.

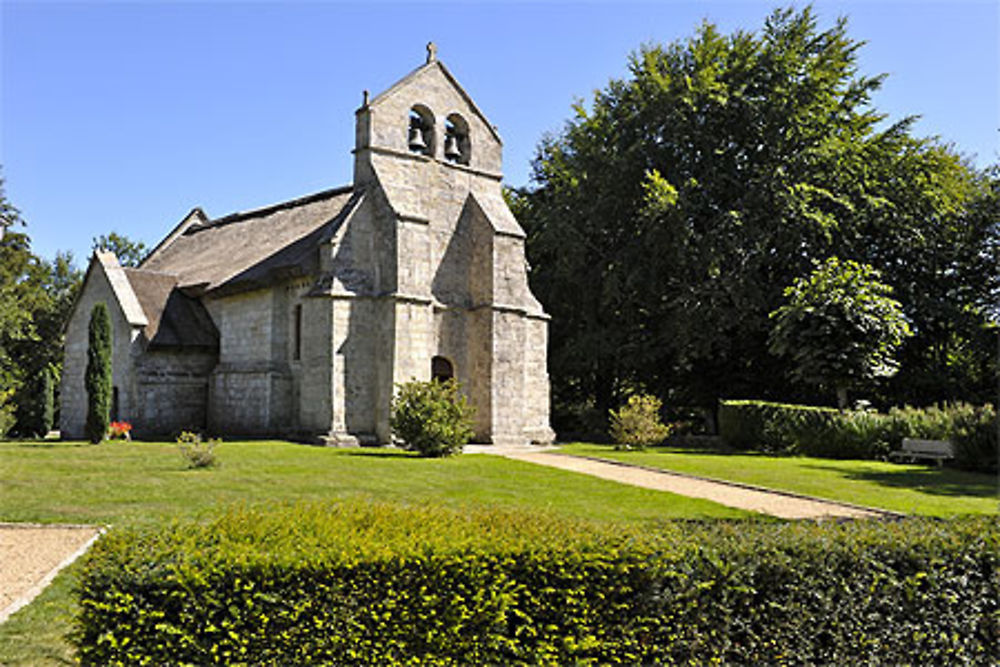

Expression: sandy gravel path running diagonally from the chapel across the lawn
xmin=496 ymin=447 xmax=896 ymax=519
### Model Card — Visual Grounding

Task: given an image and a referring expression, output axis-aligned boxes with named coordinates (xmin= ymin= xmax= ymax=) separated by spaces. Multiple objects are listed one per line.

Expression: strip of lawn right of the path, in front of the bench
xmin=561 ymin=443 xmax=1000 ymax=517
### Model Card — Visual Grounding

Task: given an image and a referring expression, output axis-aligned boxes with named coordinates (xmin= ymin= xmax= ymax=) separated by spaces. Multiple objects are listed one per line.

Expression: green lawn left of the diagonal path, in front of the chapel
xmin=0 ymin=442 xmax=750 ymax=665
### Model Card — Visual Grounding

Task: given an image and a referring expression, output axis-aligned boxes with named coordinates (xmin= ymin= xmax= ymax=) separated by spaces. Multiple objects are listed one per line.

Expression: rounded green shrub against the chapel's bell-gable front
xmin=389 ymin=379 xmax=473 ymax=456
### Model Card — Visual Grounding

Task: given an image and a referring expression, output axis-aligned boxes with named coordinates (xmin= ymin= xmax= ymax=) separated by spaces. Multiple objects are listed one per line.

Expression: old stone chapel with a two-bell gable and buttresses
xmin=60 ymin=45 xmax=553 ymax=445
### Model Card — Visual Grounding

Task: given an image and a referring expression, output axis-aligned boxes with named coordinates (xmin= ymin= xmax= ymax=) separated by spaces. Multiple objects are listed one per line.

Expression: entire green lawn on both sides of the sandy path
xmin=0 ymin=442 xmax=998 ymax=665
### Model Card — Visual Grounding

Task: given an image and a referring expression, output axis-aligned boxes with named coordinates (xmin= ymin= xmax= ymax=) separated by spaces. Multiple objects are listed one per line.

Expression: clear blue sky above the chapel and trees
xmin=0 ymin=0 xmax=1000 ymax=265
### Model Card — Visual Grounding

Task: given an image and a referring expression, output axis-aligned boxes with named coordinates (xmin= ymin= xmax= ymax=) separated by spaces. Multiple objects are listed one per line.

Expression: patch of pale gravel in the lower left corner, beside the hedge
xmin=0 ymin=523 xmax=100 ymax=623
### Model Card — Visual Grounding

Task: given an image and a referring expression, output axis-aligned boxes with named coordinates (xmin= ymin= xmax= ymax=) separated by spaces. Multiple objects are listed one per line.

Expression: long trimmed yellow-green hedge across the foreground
xmin=74 ymin=504 xmax=1000 ymax=665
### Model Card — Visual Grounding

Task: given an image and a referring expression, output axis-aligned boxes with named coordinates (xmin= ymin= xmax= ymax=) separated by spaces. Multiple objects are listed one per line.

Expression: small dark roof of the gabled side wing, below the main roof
xmin=125 ymin=269 xmax=219 ymax=348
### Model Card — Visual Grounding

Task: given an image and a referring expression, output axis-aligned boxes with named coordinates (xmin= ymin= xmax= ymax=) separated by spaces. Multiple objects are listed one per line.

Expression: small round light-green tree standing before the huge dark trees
xmin=771 ymin=257 xmax=911 ymax=409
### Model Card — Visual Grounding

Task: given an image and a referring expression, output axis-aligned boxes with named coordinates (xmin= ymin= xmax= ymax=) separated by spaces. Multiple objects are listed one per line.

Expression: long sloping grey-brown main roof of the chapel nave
xmin=139 ymin=186 xmax=352 ymax=291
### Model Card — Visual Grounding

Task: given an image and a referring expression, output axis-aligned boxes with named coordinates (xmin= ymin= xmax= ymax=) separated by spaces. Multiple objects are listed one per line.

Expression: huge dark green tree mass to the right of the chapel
xmin=513 ymin=9 xmax=997 ymax=434
